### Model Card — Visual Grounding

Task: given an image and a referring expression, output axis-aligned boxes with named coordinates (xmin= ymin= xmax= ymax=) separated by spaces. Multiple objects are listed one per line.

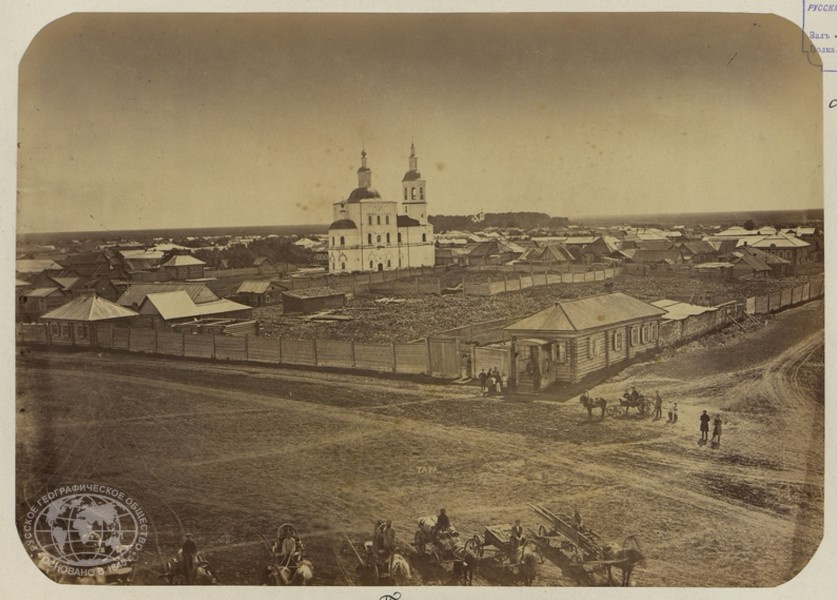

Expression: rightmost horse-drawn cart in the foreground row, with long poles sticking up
xmin=529 ymin=504 xmax=644 ymax=586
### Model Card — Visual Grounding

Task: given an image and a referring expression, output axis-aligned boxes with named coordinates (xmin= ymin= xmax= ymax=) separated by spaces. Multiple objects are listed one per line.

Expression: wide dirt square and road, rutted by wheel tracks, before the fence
xmin=17 ymin=301 xmax=823 ymax=586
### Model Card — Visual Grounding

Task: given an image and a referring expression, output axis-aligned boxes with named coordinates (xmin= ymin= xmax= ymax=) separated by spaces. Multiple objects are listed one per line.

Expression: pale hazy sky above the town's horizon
xmin=18 ymin=13 xmax=823 ymax=233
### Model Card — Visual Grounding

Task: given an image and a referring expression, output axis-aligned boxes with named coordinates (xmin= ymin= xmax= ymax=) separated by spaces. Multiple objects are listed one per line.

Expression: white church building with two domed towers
xmin=328 ymin=145 xmax=436 ymax=273
